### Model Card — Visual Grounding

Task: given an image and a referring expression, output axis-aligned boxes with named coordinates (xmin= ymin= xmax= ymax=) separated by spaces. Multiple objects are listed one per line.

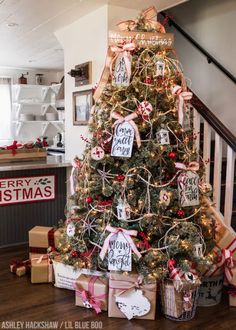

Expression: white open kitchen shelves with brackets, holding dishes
xmin=12 ymin=84 xmax=64 ymax=142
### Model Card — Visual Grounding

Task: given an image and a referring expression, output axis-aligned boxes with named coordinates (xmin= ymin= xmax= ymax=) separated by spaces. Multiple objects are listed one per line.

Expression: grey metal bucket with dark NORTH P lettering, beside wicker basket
xmin=198 ymin=274 xmax=224 ymax=307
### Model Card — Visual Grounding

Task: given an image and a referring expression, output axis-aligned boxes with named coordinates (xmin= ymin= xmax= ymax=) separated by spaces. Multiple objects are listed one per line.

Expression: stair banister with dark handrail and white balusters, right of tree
xmin=191 ymin=93 xmax=236 ymax=227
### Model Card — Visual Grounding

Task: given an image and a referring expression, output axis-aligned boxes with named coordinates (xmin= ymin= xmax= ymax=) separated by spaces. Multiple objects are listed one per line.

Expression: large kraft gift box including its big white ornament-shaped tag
xmin=108 ymin=272 xmax=157 ymax=320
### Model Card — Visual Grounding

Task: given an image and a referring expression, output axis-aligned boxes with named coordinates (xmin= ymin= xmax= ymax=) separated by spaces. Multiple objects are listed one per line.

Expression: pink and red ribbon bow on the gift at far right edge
xmin=203 ymin=249 xmax=235 ymax=283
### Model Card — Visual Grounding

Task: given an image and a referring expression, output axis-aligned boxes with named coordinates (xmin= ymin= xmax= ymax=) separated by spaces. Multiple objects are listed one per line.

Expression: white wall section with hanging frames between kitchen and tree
xmin=56 ymin=6 xmax=108 ymax=160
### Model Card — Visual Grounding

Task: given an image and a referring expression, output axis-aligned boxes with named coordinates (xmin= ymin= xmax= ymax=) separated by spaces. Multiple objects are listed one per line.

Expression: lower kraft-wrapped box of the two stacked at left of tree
xmin=31 ymin=254 xmax=53 ymax=283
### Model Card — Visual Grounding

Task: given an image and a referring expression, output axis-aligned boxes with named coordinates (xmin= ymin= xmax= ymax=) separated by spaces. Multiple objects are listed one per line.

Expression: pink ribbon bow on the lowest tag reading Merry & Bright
xmin=99 ymin=225 xmax=141 ymax=260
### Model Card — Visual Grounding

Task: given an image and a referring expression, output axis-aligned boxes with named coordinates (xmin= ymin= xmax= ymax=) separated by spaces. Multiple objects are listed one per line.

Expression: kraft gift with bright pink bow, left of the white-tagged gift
xmin=75 ymin=274 xmax=108 ymax=312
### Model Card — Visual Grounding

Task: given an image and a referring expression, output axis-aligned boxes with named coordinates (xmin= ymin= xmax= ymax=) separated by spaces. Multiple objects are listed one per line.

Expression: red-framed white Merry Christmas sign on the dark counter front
xmin=0 ymin=174 xmax=56 ymax=205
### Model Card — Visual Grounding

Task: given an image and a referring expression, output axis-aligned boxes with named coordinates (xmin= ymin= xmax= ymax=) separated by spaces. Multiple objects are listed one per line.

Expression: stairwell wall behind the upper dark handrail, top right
xmin=168 ymin=0 xmax=236 ymax=135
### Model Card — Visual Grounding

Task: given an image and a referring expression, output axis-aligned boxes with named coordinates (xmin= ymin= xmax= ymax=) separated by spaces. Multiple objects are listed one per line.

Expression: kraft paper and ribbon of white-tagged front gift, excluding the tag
xmin=108 ymin=272 xmax=157 ymax=320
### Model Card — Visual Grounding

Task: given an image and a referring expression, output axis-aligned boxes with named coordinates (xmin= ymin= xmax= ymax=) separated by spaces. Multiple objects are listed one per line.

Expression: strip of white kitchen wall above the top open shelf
xmin=0 ymin=66 xmax=64 ymax=85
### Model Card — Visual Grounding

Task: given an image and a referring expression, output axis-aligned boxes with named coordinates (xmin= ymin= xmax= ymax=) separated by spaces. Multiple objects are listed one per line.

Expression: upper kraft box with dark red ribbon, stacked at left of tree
xmin=29 ymin=226 xmax=60 ymax=254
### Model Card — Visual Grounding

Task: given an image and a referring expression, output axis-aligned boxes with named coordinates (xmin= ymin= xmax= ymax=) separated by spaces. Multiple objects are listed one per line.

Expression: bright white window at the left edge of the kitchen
xmin=0 ymin=77 xmax=12 ymax=146
